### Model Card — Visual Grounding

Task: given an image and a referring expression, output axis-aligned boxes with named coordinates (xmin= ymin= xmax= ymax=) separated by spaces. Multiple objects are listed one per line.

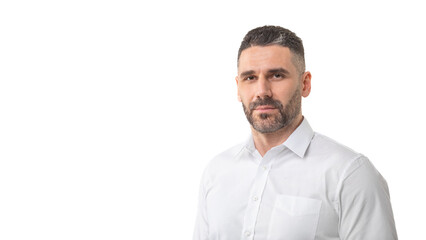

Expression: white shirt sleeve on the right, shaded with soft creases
xmin=338 ymin=156 xmax=398 ymax=240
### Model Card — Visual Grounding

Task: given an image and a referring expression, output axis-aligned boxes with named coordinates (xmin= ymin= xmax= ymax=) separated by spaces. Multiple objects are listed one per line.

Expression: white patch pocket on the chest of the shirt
xmin=268 ymin=195 xmax=321 ymax=240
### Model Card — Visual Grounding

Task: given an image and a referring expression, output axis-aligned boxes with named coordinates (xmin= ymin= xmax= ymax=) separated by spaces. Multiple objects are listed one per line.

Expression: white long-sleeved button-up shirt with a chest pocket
xmin=194 ymin=119 xmax=397 ymax=240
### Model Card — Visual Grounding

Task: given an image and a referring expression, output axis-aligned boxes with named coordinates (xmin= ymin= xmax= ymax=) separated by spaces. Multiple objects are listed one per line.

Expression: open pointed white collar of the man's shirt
xmin=245 ymin=117 xmax=314 ymax=158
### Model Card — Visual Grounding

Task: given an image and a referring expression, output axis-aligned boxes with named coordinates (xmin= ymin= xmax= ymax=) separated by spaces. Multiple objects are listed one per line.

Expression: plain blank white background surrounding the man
xmin=0 ymin=0 xmax=426 ymax=240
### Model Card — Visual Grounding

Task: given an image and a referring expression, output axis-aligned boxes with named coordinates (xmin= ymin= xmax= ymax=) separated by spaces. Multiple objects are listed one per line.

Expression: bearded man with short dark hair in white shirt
xmin=194 ymin=26 xmax=397 ymax=240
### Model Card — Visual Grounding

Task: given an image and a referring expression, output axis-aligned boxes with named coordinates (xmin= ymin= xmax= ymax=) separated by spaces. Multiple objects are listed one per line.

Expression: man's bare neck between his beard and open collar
xmin=251 ymin=115 xmax=303 ymax=157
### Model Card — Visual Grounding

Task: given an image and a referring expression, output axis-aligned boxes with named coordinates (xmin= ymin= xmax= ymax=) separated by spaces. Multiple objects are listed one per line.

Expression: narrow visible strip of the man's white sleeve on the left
xmin=193 ymin=173 xmax=208 ymax=240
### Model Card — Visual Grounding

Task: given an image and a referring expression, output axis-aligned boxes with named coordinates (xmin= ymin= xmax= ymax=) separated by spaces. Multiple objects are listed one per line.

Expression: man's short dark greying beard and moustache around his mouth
xmin=243 ymin=88 xmax=302 ymax=133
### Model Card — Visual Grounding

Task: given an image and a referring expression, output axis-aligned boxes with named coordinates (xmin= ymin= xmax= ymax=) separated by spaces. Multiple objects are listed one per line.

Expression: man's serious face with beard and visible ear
xmin=236 ymin=45 xmax=311 ymax=133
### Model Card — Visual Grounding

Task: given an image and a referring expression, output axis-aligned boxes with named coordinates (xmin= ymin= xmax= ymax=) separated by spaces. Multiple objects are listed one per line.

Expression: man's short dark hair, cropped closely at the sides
xmin=237 ymin=26 xmax=305 ymax=73
